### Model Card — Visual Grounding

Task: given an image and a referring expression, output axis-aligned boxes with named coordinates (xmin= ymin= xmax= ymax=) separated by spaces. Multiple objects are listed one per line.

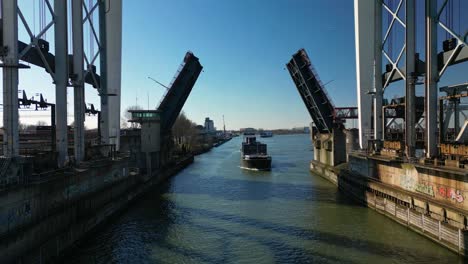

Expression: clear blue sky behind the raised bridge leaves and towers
xmin=3 ymin=0 xmax=468 ymax=129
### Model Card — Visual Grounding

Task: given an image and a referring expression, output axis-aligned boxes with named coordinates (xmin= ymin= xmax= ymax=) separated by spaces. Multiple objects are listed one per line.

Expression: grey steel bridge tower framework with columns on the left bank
xmin=0 ymin=0 xmax=122 ymax=167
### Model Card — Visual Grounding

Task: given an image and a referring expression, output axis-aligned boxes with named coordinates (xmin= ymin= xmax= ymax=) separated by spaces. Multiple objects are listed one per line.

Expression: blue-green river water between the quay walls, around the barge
xmin=66 ymin=135 xmax=463 ymax=264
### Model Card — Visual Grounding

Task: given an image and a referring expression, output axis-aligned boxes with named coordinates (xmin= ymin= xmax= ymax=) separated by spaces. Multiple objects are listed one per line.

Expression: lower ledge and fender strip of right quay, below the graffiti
xmin=310 ymin=161 xmax=468 ymax=256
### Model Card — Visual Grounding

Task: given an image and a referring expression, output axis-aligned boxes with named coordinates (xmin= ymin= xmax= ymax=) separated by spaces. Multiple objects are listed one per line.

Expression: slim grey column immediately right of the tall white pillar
xmin=374 ymin=0 xmax=385 ymax=144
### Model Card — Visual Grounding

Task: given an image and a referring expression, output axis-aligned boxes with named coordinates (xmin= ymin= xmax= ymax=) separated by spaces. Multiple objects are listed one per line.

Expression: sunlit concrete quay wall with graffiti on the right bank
xmin=310 ymin=154 xmax=468 ymax=255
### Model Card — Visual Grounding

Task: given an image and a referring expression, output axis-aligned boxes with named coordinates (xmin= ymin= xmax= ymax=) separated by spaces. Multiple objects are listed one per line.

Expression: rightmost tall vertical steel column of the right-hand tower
xmin=425 ymin=0 xmax=439 ymax=158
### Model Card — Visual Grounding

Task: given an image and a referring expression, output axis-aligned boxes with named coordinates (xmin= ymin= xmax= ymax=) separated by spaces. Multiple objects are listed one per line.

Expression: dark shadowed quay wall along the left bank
xmin=0 ymin=155 xmax=194 ymax=263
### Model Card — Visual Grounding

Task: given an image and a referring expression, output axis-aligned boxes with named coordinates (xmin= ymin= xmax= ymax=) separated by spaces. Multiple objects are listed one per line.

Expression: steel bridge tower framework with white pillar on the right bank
xmin=354 ymin=0 xmax=468 ymax=159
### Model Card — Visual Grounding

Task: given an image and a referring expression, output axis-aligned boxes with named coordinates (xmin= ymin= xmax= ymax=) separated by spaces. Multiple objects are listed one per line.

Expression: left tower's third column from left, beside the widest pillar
xmin=72 ymin=0 xmax=86 ymax=163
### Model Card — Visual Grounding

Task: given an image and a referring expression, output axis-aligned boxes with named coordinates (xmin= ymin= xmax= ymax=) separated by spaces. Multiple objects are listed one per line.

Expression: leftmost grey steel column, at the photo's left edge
xmin=0 ymin=0 xmax=19 ymax=157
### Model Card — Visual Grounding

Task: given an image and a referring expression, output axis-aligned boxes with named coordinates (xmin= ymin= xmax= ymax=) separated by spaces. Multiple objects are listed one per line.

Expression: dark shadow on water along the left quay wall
xmin=63 ymin=181 xmax=180 ymax=264
